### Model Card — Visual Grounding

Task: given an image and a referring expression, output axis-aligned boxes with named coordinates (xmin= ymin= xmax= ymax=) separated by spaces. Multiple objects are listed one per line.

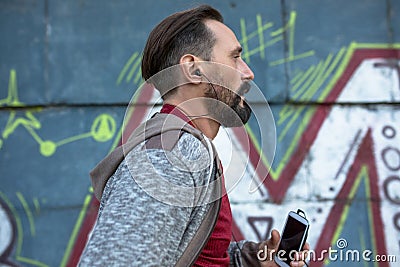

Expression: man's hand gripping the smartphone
xmin=257 ymin=230 xmax=310 ymax=267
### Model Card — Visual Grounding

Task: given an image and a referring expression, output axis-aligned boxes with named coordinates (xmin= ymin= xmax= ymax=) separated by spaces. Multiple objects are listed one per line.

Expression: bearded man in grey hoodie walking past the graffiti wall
xmin=80 ymin=6 xmax=308 ymax=266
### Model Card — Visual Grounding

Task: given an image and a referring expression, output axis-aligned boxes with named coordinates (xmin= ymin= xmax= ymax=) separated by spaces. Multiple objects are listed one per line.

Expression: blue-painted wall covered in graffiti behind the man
xmin=0 ymin=0 xmax=400 ymax=266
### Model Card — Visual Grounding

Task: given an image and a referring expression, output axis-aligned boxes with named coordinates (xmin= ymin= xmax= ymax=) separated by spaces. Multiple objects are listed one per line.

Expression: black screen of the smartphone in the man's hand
xmin=278 ymin=216 xmax=307 ymax=265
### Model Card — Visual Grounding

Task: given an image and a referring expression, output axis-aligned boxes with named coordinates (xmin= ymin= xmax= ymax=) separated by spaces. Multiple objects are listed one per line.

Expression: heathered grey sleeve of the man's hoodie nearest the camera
xmin=80 ymin=134 xmax=214 ymax=266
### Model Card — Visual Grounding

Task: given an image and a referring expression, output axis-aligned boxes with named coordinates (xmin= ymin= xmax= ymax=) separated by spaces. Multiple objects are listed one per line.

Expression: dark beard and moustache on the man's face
xmin=206 ymin=82 xmax=252 ymax=128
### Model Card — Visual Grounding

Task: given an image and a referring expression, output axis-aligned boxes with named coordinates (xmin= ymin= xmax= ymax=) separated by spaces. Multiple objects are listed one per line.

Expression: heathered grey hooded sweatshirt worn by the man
xmin=79 ymin=114 xmax=259 ymax=266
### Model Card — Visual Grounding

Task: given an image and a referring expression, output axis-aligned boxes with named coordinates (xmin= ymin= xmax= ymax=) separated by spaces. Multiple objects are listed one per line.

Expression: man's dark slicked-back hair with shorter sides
xmin=142 ymin=5 xmax=223 ymax=80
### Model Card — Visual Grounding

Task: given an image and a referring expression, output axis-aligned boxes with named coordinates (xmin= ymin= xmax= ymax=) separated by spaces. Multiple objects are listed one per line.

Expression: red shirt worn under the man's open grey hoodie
xmin=161 ymin=104 xmax=232 ymax=267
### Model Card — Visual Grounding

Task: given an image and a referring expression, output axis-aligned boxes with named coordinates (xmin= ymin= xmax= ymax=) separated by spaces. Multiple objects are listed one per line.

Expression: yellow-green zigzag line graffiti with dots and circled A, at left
xmin=0 ymin=69 xmax=117 ymax=157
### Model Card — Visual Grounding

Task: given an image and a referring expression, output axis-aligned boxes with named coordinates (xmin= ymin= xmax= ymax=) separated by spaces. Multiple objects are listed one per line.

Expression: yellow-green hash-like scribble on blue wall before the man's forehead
xmin=240 ymin=11 xmax=315 ymax=66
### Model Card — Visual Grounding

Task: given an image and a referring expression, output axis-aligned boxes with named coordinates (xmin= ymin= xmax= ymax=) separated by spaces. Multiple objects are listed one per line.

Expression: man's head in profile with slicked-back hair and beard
xmin=142 ymin=6 xmax=254 ymax=126
